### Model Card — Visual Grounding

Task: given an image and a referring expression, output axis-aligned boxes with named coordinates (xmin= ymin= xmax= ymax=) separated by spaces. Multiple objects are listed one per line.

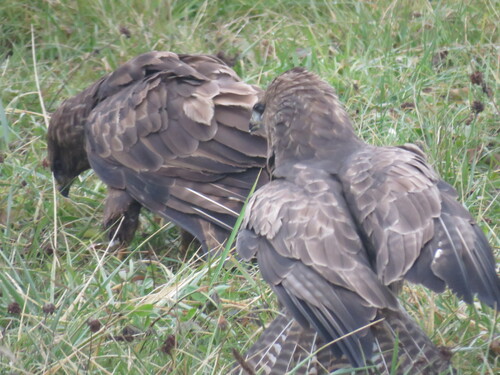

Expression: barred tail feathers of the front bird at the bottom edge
xmin=230 ymin=309 xmax=454 ymax=375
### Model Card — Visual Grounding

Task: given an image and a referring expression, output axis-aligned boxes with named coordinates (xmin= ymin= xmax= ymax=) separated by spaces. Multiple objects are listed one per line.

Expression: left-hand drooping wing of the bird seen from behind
xmin=237 ymin=165 xmax=447 ymax=373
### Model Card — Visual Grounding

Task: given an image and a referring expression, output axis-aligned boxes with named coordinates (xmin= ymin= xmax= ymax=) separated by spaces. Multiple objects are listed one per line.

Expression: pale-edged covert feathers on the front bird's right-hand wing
xmin=339 ymin=146 xmax=441 ymax=285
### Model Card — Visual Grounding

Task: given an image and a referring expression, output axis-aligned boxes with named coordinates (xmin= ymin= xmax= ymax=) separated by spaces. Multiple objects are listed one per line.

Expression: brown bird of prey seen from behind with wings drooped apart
xmin=237 ymin=68 xmax=500 ymax=374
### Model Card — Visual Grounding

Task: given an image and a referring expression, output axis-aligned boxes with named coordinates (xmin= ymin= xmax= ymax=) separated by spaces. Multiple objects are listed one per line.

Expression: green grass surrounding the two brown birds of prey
xmin=0 ymin=0 xmax=500 ymax=375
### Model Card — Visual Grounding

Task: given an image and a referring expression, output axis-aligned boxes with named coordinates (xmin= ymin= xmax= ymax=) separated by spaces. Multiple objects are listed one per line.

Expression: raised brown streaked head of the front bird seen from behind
xmin=250 ymin=68 xmax=357 ymax=171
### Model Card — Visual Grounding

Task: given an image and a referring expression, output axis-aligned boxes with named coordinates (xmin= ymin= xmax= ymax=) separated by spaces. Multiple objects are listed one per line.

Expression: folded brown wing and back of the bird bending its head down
xmin=81 ymin=52 xmax=267 ymax=251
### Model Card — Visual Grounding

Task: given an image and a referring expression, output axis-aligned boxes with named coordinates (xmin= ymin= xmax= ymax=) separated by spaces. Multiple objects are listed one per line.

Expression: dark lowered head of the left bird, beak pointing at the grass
xmin=47 ymin=101 xmax=90 ymax=197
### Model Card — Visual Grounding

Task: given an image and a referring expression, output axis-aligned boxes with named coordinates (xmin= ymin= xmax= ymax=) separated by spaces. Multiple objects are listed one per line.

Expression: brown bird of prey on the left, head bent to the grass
xmin=48 ymin=52 xmax=267 ymax=251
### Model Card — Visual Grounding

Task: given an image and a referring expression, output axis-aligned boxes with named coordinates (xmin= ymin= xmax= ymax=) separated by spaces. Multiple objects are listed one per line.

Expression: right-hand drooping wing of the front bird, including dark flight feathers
xmin=339 ymin=145 xmax=500 ymax=307
